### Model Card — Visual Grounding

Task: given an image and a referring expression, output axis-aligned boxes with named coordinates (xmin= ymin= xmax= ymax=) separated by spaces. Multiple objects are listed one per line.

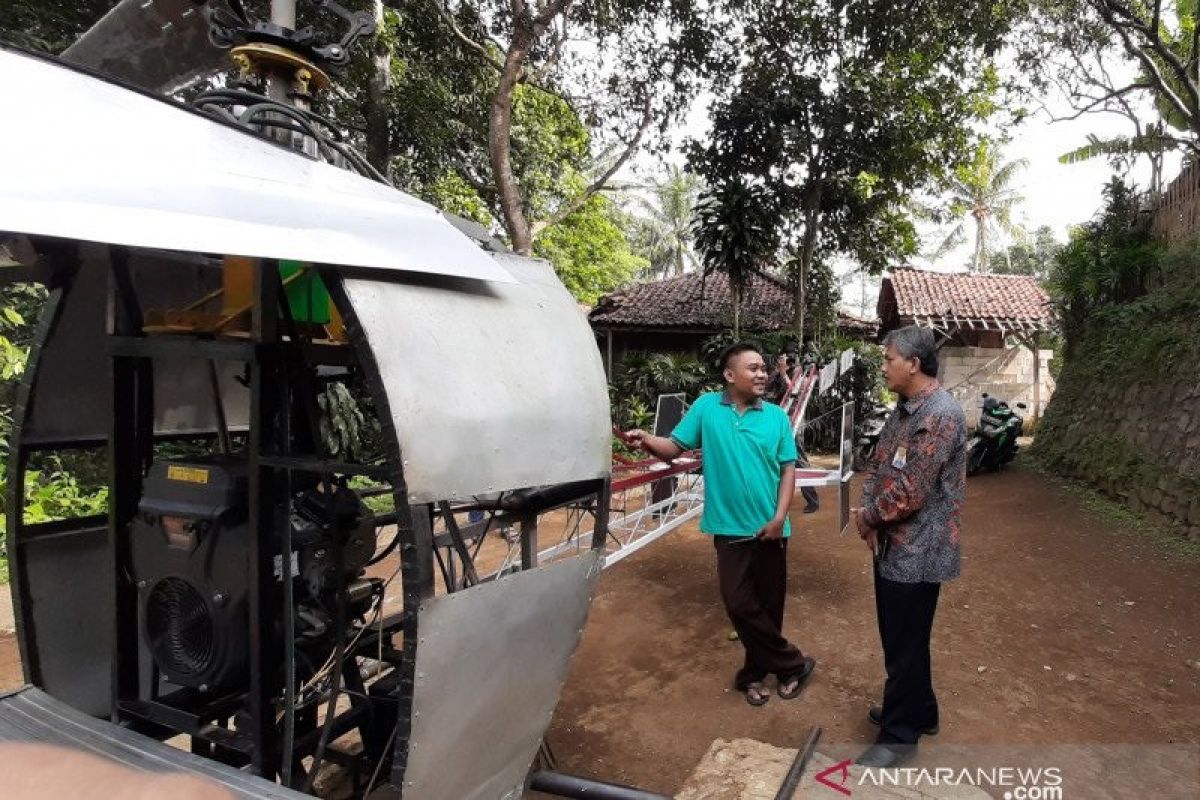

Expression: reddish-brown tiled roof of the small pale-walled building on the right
xmin=878 ymin=267 xmax=1054 ymax=330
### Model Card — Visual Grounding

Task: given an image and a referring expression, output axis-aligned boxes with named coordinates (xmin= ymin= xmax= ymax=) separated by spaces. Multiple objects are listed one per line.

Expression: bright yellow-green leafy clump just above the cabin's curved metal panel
xmin=533 ymin=194 xmax=648 ymax=305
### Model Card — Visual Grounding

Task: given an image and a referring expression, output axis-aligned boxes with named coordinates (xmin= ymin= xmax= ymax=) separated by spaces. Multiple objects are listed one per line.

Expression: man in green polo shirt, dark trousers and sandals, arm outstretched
xmin=626 ymin=344 xmax=816 ymax=705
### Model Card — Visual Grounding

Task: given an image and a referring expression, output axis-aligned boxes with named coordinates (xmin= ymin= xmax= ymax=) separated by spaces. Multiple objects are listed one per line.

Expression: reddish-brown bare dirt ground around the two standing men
xmin=0 ymin=468 xmax=1200 ymax=794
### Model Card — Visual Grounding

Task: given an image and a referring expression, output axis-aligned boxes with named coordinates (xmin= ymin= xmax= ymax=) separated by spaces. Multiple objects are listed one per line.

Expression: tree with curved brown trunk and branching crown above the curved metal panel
xmin=398 ymin=0 xmax=715 ymax=254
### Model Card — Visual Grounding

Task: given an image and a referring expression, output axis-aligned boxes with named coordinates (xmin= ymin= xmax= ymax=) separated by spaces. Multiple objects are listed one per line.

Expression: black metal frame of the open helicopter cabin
xmin=7 ymin=240 xmax=610 ymax=796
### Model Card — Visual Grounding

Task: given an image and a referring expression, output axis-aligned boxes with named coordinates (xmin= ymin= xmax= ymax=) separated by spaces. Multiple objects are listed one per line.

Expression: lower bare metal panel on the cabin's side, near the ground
xmin=404 ymin=552 xmax=600 ymax=800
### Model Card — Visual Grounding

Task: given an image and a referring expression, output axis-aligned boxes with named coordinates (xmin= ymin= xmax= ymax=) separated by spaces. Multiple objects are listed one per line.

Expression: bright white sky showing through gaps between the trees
xmin=622 ymin=49 xmax=1180 ymax=317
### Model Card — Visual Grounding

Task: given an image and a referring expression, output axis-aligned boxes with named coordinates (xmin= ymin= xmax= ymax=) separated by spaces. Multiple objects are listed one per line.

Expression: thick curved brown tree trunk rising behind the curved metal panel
xmin=487 ymin=28 xmax=533 ymax=255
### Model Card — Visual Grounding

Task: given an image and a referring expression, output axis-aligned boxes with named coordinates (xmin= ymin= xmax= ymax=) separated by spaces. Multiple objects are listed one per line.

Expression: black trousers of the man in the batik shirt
xmin=875 ymin=566 xmax=942 ymax=745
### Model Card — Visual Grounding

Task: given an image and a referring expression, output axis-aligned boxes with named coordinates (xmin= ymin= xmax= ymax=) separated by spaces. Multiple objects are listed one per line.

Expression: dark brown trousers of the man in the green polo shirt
xmin=713 ymin=536 xmax=804 ymax=691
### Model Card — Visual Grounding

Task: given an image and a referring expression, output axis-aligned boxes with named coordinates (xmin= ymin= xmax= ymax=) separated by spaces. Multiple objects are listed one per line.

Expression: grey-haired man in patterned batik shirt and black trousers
xmin=854 ymin=326 xmax=966 ymax=768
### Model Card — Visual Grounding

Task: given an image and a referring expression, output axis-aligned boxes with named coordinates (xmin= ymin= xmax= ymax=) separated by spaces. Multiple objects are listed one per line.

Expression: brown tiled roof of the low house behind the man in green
xmin=588 ymin=272 xmax=875 ymax=332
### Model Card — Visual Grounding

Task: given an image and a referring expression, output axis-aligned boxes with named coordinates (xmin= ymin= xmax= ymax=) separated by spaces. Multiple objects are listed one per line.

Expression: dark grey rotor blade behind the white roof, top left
xmin=62 ymin=0 xmax=229 ymax=94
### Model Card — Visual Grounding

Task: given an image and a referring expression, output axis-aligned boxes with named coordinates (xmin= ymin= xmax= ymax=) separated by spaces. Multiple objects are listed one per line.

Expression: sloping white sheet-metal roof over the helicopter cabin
xmin=0 ymin=47 xmax=511 ymax=282
